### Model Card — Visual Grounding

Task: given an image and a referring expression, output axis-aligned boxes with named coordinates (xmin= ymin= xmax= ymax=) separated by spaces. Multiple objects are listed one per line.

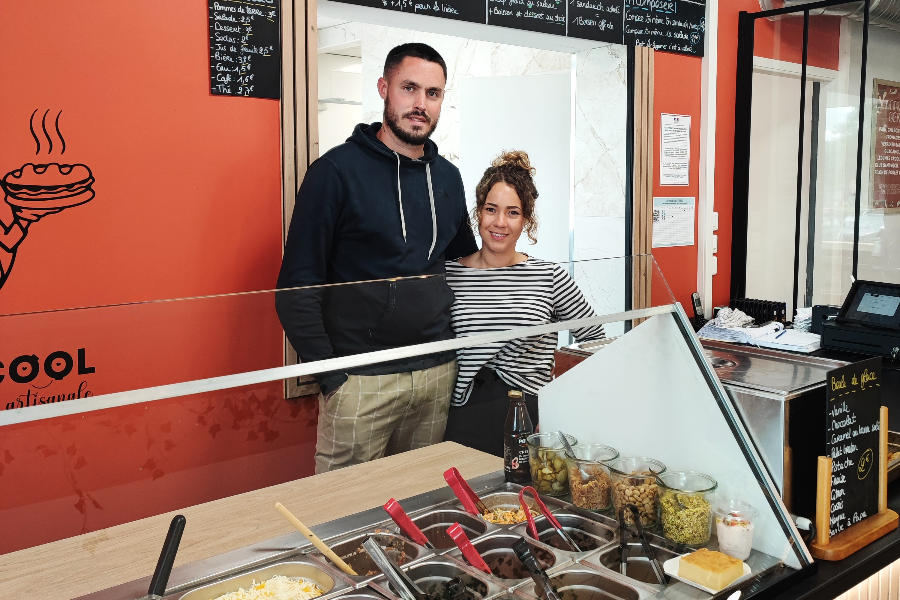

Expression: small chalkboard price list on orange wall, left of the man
xmin=209 ymin=0 xmax=281 ymax=99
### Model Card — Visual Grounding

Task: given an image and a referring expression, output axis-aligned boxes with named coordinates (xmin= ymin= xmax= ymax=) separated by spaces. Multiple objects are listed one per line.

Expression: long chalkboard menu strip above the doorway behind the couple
xmin=337 ymin=0 xmax=706 ymax=56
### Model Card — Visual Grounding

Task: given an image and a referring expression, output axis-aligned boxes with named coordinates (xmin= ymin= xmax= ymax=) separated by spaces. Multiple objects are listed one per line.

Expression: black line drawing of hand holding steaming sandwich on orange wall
xmin=0 ymin=110 xmax=94 ymax=289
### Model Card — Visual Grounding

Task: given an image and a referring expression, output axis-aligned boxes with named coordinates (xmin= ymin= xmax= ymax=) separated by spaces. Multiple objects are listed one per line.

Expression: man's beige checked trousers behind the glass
xmin=316 ymin=360 xmax=458 ymax=473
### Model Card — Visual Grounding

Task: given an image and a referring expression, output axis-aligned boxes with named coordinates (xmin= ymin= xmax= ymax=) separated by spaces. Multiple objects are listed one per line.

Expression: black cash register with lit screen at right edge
xmin=822 ymin=279 xmax=900 ymax=359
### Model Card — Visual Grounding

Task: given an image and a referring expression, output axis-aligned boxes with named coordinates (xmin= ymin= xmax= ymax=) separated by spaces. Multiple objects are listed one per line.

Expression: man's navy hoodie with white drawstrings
xmin=275 ymin=123 xmax=478 ymax=394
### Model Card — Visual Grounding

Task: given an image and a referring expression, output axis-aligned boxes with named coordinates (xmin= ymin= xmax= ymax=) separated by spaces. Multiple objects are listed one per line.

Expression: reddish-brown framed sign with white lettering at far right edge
xmin=869 ymin=79 xmax=900 ymax=212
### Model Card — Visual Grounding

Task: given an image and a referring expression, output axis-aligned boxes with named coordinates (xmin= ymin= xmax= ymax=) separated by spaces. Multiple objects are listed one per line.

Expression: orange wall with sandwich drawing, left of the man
xmin=0 ymin=0 xmax=316 ymax=553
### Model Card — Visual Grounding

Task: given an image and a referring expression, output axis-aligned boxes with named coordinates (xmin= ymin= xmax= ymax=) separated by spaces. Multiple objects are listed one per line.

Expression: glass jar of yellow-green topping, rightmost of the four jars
xmin=658 ymin=471 xmax=718 ymax=546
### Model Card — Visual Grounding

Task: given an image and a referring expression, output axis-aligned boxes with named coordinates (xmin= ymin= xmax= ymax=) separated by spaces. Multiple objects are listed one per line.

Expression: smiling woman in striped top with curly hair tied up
xmin=444 ymin=151 xmax=604 ymax=456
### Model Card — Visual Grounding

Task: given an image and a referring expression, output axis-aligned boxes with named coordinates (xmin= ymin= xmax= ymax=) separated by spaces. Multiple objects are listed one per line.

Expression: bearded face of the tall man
xmin=378 ymin=56 xmax=447 ymax=146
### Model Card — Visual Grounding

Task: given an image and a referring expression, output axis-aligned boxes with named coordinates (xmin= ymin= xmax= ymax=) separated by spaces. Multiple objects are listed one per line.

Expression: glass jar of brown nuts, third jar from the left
xmin=606 ymin=456 xmax=666 ymax=527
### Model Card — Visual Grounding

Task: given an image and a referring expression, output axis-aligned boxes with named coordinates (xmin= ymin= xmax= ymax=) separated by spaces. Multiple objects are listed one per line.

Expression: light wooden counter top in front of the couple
xmin=0 ymin=442 xmax=503 ymax=600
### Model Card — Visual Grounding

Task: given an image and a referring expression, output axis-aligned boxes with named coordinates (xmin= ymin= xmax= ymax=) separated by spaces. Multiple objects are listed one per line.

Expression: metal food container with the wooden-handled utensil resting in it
xmin=309 ymin=530 xmax=434 ymax=587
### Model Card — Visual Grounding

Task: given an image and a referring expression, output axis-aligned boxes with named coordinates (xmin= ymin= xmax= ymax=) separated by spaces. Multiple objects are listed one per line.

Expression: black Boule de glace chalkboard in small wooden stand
xmin=826 ymin=358 xmax=881 ymax=535
